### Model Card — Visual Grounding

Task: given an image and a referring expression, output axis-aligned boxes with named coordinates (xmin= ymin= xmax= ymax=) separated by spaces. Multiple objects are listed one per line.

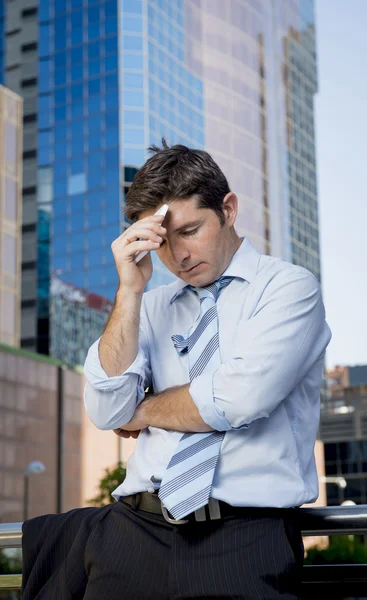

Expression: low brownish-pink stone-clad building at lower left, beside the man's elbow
xmin=0 ymin=345 xmax=125 ymax=523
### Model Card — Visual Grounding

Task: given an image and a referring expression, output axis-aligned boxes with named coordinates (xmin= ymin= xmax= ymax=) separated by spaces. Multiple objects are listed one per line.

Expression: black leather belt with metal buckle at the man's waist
xmin=120 ymin=492 xmax=296 ymax=525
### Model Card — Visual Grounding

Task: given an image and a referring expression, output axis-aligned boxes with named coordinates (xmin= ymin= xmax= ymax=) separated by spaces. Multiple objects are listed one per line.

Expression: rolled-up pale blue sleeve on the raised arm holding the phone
xmin=84 ymin=312 xmax=151 ymax=429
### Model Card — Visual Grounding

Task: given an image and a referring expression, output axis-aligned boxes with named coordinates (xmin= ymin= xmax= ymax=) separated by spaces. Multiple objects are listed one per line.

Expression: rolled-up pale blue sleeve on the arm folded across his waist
xmin=190 ymin=270 xmax=331 ymax=431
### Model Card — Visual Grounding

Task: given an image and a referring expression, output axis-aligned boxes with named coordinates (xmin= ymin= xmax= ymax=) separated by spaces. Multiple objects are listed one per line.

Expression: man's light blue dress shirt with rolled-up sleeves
xmin=85 ymin=238 xmax=331 ymax=507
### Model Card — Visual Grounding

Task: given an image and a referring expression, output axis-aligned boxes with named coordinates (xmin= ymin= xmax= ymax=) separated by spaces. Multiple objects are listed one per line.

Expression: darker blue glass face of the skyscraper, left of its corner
xmin=38 ymin=0 xmax=120 ymax=363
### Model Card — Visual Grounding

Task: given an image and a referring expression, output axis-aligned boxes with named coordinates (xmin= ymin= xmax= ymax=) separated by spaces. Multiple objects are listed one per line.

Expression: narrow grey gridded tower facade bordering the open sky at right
xmin=286 ymin=0 xmax=321 ymax=279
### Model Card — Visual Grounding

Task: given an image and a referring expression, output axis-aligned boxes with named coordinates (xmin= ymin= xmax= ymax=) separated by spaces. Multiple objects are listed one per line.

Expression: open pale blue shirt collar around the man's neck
xmin=170 ymin=238 xmax=261 ymax=304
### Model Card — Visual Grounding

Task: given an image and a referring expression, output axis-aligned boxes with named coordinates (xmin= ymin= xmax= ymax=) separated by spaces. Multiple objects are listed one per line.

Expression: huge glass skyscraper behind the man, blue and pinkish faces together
xmin=0 ymin=0 xmax=320 ymax=364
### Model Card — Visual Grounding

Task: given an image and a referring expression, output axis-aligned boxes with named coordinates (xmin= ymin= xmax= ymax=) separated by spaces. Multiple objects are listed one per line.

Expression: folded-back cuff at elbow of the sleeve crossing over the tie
xmin=189 ymin=373 xmax=233 ymax=431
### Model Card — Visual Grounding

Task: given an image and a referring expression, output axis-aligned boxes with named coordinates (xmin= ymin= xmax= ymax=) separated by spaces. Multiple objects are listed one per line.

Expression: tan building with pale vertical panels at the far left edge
xmin=0 ymin=85 xmax=23 ymax=346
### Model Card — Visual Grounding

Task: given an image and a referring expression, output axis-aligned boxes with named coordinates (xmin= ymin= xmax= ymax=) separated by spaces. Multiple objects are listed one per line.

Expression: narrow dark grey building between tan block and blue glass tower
xmin=0 ymin=0 xmax=43 ymax=350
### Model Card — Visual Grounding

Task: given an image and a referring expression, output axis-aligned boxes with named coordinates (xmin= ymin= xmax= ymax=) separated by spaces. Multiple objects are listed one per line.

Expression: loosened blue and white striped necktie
xmin=158 ymin=277 xmax=233 ymax=519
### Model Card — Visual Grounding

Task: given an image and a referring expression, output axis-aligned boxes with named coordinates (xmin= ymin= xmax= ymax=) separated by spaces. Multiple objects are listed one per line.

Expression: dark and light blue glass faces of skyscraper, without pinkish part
xmin=45 ymin=0 xmax=204 ymax=363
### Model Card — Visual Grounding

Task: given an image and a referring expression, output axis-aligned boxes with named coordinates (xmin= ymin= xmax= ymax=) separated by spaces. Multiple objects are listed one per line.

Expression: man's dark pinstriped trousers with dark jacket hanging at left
xmin=23 ymin=502 xmax=303 ymax=600
